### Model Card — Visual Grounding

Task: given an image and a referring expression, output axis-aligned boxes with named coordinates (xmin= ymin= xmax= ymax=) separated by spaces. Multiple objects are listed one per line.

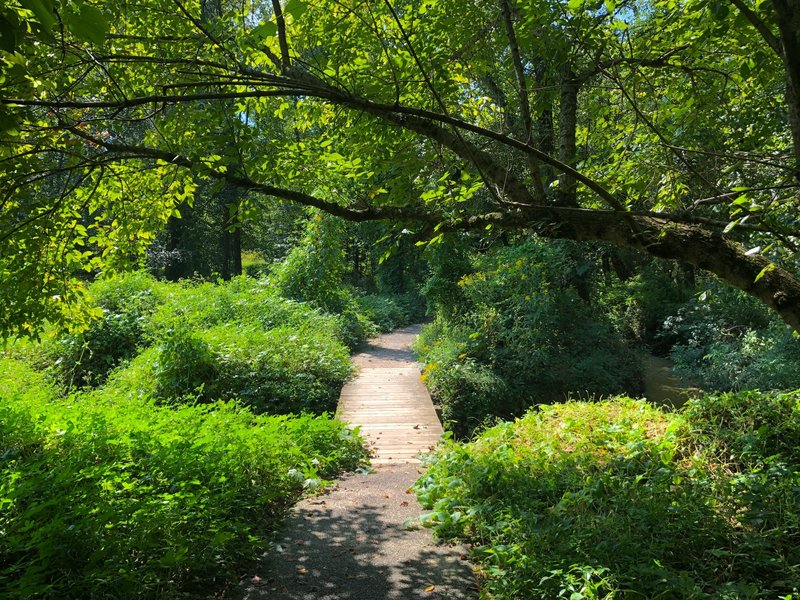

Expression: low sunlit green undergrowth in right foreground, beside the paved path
xmin=415 ymin=393 xmax=800 ymax=599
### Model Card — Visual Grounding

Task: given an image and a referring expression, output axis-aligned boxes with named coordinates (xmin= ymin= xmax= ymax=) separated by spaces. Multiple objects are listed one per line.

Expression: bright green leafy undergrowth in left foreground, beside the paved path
xmin=0 ymin=360 xmax=364 ymax=598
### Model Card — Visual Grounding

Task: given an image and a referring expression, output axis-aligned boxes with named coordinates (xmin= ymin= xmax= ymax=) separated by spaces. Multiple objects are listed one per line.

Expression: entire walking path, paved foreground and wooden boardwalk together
xmin=241 ymin=326 xmax=477 ymax=600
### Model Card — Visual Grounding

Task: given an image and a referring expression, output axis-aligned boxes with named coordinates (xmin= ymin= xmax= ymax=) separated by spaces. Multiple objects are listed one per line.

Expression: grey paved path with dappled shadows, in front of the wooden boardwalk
xmin=240 ymin=465 xmax=477 ymax=600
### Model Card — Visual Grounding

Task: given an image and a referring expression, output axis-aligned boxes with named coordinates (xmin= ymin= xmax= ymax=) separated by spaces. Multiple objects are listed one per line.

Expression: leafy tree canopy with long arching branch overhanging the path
xmin=0 ymin=0 xmax=800 ymax=334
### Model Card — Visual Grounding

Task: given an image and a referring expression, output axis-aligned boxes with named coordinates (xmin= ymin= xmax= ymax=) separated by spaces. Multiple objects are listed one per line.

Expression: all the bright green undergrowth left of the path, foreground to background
xmin=0 ymin=273 xmax=382 ymax=599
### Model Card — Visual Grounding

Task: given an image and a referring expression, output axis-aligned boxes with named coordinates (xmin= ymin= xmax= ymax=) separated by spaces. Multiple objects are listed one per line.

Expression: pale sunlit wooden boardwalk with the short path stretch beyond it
xmin=338 ymin=325 xmax=442 ymax=465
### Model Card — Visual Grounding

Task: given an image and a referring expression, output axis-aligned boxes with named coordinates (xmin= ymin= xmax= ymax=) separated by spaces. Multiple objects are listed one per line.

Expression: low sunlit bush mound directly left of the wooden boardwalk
xmin=104 ymin=323 xmax=350 ymax=414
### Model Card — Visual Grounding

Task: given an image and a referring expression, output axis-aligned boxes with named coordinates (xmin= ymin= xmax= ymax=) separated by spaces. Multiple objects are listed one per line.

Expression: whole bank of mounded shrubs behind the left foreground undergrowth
xmin=10 ymin=273 xmax=358 ymax=414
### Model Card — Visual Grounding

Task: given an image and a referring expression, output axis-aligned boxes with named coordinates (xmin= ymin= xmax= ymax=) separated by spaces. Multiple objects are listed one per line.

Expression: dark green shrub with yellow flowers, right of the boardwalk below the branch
xmin=418 ymin=241 xmax=641 ymax=434
